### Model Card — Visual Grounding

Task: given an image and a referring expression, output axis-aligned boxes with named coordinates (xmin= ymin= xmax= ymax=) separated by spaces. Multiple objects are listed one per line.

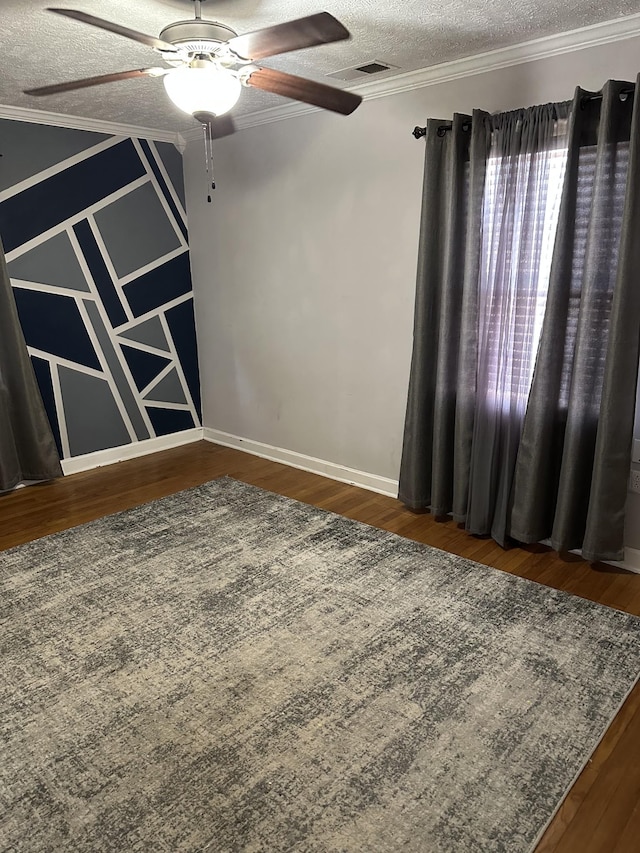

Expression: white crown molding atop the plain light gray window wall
xmin=182 ymin=14 xmax=640 ymax=142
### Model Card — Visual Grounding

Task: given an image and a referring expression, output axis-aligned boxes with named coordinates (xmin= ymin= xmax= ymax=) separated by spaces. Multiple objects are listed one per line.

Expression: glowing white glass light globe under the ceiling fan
xmin=163 ymin=62 xmax=242 ymax=116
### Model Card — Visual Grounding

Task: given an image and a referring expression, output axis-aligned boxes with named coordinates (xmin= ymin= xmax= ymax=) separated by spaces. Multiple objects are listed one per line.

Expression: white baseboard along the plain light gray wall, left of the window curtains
xmin=204 ymin=427 xmax=398 ymax=498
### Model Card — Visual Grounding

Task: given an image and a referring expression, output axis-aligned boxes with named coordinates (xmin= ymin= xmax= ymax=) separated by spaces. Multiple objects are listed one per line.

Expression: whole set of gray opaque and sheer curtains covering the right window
xmin=399 ymin=76 xmax=640 ymax=559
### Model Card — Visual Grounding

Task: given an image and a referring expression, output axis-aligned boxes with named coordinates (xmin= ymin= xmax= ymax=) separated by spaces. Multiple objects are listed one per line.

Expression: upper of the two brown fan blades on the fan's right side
xmin=227 ymin=12 xmax=350 ymax=59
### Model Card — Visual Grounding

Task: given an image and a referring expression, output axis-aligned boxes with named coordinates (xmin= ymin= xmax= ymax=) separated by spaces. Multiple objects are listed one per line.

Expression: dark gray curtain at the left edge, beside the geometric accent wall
xmin=0 ymin=244 xmax=62 ymax=492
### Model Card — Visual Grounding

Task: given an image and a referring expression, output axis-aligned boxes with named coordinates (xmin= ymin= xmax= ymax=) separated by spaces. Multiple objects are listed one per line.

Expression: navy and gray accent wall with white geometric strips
xmin=0 ymin=121 xmax=200 ymax=458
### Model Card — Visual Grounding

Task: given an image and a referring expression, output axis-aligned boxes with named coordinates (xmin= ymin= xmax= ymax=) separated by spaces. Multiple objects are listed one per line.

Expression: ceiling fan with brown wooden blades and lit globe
xmin=25 ymin=0 xmax=362 ymax=137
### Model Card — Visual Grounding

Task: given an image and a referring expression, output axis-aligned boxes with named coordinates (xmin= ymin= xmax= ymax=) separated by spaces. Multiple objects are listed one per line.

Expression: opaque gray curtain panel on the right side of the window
xmin=511 ymin=78 xmax=640 ymax=560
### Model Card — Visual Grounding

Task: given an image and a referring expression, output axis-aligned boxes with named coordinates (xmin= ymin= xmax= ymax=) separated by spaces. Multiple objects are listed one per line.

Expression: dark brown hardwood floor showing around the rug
xmin=0 ymin=442 xmax=640 ymax=853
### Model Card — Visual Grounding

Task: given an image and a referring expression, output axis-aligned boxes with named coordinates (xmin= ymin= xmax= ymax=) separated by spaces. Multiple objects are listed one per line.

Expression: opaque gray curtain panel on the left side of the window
xmin=399 ymin=110 xmax=485 ymax=516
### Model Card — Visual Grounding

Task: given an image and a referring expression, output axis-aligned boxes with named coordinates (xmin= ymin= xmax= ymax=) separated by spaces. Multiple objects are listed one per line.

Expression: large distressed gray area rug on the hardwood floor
xmin=0 ymin=478 xmax=640 ymax=853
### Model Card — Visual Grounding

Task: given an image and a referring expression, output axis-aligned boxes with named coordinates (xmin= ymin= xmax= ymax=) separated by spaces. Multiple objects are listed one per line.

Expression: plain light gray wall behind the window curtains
xmin=185 ymin=31 xmax=640 ymax=548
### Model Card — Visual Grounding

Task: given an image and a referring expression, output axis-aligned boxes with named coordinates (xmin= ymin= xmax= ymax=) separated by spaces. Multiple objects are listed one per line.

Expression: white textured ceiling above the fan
xmin=0 ymin=0 xmax=640 ymax=131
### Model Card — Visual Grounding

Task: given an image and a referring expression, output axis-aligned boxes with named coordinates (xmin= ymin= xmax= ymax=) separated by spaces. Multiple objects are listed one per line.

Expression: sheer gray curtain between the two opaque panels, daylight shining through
xmin=466 ymin=104 xmax=568 ymax=545
